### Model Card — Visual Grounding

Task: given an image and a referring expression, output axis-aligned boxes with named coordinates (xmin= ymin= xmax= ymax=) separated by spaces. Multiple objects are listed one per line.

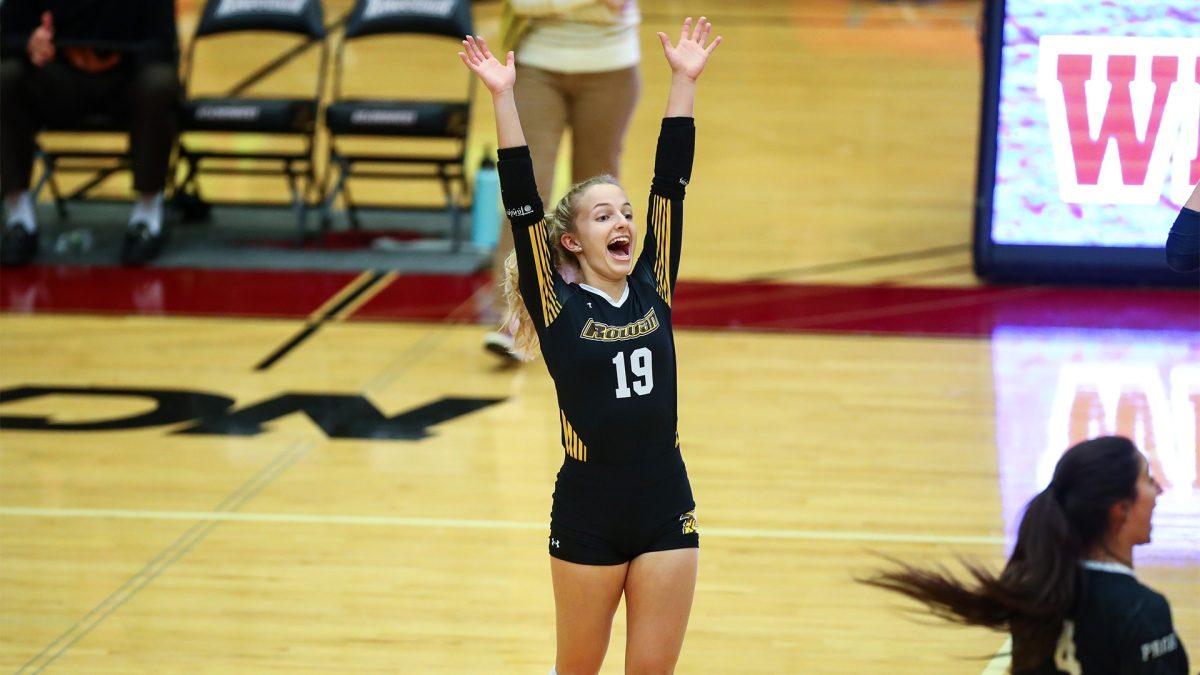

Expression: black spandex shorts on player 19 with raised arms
xmin=550 ymin=450 xmax=700 ymax=565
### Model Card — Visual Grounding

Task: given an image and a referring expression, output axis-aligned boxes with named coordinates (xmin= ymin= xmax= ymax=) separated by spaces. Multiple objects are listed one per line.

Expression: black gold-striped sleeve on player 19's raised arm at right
xmin=637 ymin=118 xmax=696 ymax=305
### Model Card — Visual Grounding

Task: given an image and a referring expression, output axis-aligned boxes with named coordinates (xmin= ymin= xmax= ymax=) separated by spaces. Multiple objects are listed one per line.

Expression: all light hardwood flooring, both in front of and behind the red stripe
xmin=0 ymin=0 xmax=1200 ymax=675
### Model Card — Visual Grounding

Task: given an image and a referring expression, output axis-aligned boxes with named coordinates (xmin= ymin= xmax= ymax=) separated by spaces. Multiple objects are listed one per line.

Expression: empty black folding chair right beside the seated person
xmin=175 ymin=0 xmax=329 ymax=240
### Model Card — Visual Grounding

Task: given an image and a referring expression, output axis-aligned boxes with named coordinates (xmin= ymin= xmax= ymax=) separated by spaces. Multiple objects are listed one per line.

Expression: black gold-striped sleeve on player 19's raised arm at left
xmin=496 ymin=145 xmax=563 ymax=331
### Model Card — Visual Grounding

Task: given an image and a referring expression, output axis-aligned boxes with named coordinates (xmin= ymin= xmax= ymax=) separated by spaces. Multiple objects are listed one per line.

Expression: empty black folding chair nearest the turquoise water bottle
xmin=322 ymin=0 xmax=474 ymax=251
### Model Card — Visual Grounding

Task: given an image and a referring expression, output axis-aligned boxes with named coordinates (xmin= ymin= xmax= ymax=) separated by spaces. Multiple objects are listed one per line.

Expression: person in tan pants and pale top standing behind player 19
xmin=484 ymin=0 xmax=641 ymax=363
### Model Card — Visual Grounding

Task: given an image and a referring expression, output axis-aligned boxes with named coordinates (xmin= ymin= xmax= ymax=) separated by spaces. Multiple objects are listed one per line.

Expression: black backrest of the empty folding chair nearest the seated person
xmin=196 ymin=0 xmax=325 ymax=40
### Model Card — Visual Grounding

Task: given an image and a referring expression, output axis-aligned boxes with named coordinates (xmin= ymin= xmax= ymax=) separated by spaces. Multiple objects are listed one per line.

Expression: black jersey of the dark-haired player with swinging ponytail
xmin=1026 ymin=561 xmax=1188 ymax=675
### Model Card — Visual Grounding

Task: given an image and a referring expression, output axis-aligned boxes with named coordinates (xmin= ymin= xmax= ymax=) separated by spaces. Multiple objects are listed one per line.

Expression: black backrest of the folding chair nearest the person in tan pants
xmin=346 ymin=0 xmax=474 ymax=40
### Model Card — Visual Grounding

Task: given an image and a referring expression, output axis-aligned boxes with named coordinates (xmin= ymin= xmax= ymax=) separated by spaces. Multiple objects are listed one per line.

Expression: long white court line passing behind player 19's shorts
xmin=0 ymin=507 xmax=1004 ymax=545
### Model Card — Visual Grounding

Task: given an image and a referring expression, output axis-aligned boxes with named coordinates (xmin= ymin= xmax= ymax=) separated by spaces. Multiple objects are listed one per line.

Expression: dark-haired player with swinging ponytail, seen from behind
xmin=864 ymin=436 xmax=1188 ymax=675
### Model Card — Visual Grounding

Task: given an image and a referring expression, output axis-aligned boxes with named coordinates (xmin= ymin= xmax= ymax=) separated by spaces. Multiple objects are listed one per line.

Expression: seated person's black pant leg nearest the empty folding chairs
xmin=126 ymin=62 xmax=180 ymax=193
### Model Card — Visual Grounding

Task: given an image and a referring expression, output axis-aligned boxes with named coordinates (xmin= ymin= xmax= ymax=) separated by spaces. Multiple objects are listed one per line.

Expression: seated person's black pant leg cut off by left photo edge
xmin=0 ymin=58 xmax=37 ymax=197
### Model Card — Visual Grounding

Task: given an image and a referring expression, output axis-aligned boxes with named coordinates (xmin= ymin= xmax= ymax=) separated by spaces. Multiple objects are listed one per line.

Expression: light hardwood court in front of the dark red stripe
xmin=0 ymin=307 xmax=1200 ymax=673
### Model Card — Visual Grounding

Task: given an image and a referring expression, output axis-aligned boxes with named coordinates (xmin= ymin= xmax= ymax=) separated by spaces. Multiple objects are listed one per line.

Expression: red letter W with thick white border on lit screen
xmin=1038 ymin=35 xmax=1200 ymax=204
